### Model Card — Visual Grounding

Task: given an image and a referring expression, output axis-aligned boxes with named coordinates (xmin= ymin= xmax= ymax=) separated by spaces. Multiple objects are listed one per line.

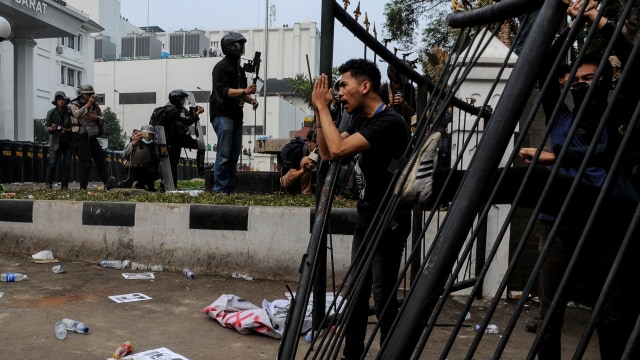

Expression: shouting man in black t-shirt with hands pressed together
xmin=312 ymin=59 xmax=411 ymax=359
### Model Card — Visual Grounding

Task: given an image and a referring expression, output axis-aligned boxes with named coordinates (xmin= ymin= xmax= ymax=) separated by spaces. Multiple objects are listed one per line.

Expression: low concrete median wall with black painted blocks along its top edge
xmin=0 ymin=200 xmax=356 ymax=281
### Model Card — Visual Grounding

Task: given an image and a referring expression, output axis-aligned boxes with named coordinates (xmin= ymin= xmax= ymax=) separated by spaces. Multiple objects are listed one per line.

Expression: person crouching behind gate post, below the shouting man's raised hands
xmin=280 ymin=131 xmax=319 ymax=195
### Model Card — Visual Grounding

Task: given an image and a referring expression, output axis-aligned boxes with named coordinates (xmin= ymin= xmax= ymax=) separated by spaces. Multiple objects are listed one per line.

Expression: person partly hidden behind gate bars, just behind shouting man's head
xmin=380 ymin=65 xmax=416 ymax=127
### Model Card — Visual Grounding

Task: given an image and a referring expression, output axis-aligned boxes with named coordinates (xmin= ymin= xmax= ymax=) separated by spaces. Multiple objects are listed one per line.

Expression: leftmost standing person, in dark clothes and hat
xmin=44 ymin=91 xmax=71 ymax=189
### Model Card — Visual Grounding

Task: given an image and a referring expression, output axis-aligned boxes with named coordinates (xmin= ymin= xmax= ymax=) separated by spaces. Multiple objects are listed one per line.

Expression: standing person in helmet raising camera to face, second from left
xmin=71 ymin=85 xmax=117 ymax=190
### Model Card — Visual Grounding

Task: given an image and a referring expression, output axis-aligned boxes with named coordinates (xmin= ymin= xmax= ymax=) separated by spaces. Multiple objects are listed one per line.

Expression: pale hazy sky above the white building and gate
xmin=120 ymin=0 xmax=388 ymax=76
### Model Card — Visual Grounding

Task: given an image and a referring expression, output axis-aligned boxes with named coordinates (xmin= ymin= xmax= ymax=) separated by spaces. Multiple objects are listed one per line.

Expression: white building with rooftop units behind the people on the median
xmin=0 ymin=0 xmax=320 ymax=169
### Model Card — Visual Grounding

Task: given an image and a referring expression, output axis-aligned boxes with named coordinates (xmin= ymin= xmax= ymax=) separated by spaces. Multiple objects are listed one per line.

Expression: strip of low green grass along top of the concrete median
xmin=0 ymin=179 xmax=356 ymax=208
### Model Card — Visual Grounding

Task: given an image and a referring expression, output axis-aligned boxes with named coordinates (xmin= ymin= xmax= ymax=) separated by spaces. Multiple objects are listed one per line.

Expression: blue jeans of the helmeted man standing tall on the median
xmin=213 ymin=116 xmax=242 ymax=193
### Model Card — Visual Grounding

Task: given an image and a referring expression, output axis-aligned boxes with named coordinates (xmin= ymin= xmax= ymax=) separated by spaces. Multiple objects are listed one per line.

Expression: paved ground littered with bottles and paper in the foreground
xmin=0 ymin=253 xmax=599 ymax=360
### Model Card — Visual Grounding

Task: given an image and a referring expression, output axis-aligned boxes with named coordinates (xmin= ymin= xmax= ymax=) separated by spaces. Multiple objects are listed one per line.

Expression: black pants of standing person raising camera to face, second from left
xmin=73 ymin=134 xmax=109 ymax=190
